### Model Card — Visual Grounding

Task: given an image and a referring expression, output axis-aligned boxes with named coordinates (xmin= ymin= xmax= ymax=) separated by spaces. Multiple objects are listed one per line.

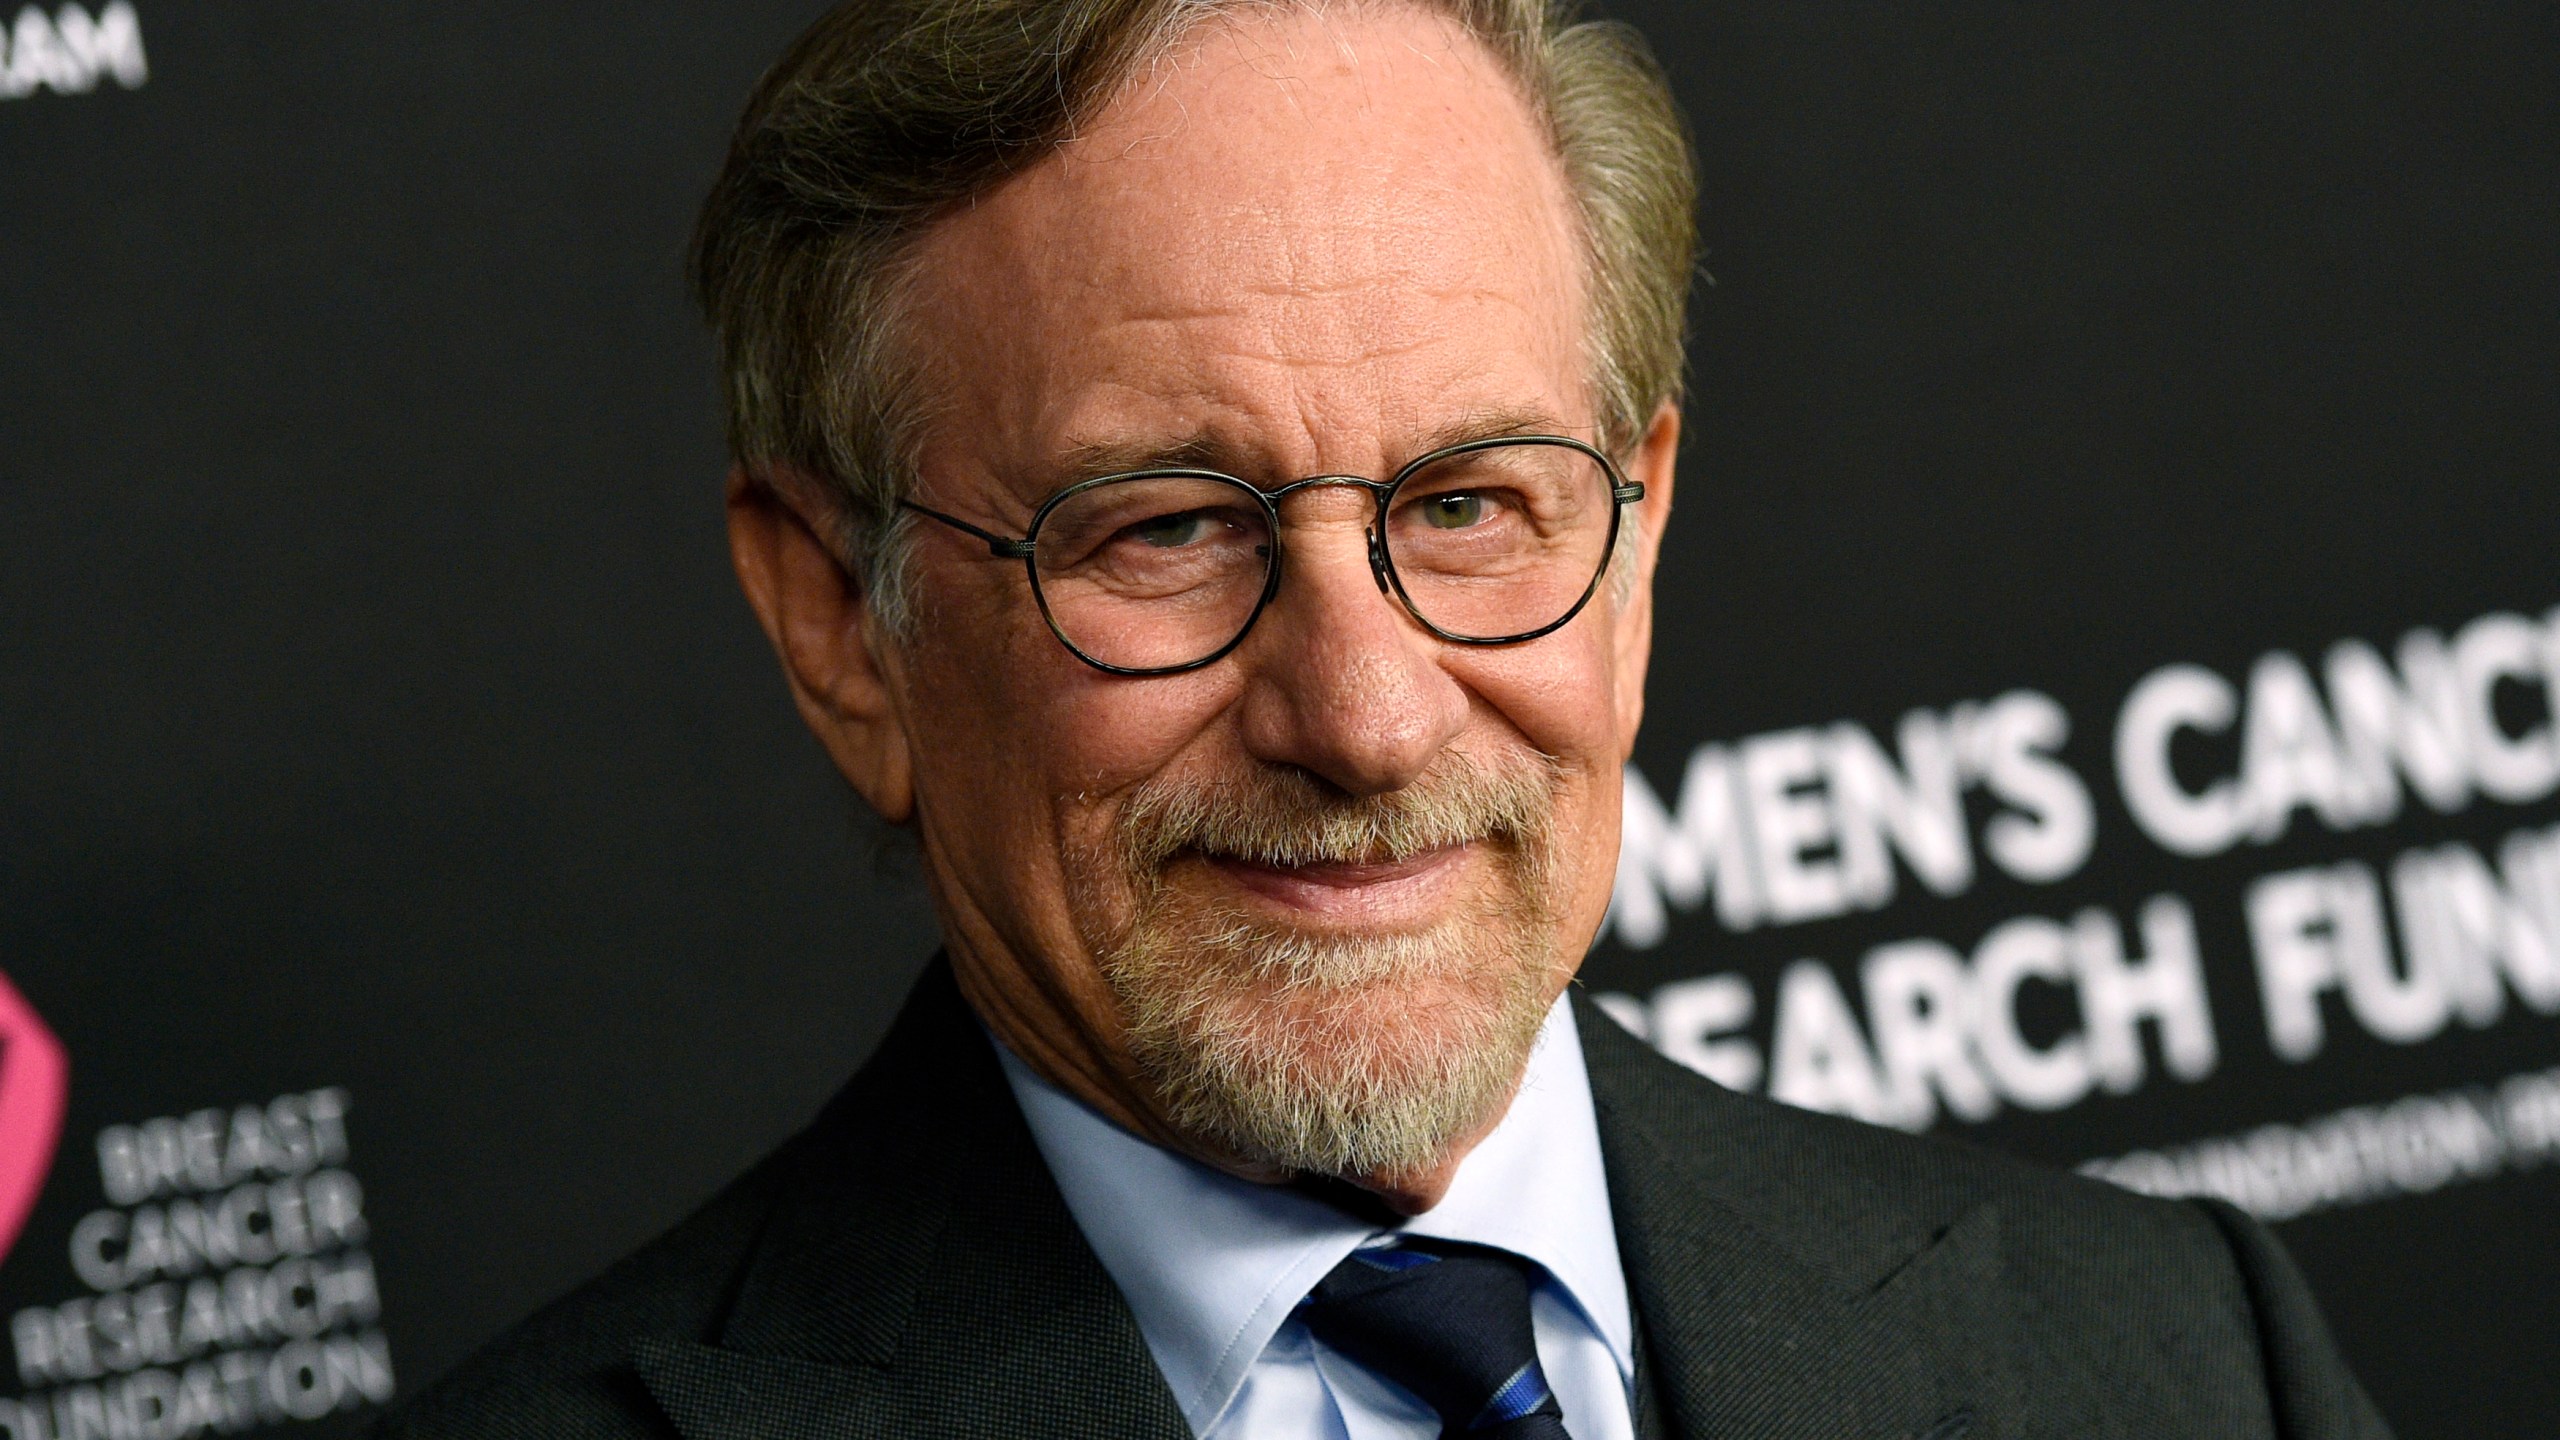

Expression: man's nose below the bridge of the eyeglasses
xmin=1236 ymin=489 xmax=1469 ymax=794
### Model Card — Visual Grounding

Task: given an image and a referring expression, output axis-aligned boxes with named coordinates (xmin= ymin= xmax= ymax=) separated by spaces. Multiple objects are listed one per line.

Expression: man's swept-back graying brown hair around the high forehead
xmin=691 ymin=0 xmax=1697 ymax=633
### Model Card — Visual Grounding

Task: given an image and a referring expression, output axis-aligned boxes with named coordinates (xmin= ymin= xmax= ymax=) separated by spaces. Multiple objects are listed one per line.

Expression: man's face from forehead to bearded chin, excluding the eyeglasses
xmin=750 ymin=8 xmax=1677 ymax=1199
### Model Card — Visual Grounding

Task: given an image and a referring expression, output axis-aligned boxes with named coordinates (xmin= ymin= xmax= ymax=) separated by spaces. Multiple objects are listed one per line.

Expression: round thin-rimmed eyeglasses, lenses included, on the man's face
xmin=901 ymin=436 xmax=1644 ymax=674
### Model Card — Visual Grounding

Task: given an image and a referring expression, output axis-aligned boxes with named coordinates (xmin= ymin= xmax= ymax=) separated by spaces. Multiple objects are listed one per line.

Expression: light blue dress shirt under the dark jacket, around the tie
xmin=996 ymin=983 xmax=1636 ymax=1440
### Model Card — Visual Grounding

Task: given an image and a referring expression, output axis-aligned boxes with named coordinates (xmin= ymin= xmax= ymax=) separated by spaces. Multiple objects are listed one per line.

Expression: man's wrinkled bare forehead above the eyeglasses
xmin=911 ymin=8 xmax=1587 ymax=486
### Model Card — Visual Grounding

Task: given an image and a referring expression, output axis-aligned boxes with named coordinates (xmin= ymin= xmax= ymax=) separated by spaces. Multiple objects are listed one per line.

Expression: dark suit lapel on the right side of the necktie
xmin=1577 ymin=983 xmax=2012 ymax=1440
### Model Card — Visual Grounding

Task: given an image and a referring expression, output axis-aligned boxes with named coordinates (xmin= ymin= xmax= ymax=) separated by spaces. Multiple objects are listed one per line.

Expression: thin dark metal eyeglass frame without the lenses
xmin=899 ymin=436 xmax=1644 ymax=676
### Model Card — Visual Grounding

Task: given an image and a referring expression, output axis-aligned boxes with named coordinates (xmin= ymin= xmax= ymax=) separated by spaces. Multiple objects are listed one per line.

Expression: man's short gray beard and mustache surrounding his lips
xmin=1096 ymin=764 xmax=1556 ymax=1179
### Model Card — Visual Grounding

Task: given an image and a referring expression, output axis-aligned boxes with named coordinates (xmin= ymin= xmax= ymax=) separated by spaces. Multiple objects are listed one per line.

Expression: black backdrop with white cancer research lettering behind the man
xmin=0 ymin=0 xmax=2560 ymax=1437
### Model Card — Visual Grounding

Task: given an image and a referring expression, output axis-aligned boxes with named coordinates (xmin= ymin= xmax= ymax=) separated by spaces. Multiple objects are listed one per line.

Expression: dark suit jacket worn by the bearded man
xmin=384 ymin=963 xmax=2386 ymax=1440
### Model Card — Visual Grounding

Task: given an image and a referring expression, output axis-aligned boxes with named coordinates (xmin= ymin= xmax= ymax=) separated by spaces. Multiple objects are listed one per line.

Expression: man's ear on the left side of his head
xmin=727 ymin=466 xmax=916 ymax=825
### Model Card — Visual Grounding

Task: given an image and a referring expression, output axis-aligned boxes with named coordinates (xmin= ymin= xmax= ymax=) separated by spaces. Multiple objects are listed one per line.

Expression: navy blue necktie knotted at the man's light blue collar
xmin=1298 ymin=1240 xmax=1572 ymax=1440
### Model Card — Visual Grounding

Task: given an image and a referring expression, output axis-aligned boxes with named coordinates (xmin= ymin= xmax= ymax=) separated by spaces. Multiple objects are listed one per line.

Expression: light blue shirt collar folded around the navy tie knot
xmin=996 ymin=997 xmax=1636 ymax=1432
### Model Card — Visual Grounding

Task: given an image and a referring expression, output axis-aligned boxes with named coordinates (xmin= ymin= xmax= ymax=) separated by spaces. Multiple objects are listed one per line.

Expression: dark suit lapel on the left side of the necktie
xmin=632 ymin=961 xmax=1190 ymax=1440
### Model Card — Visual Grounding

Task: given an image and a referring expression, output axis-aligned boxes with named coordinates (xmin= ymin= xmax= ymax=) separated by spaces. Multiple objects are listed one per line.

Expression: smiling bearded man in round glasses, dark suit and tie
xmin=392 ymin=0 xmax=2383 ymax=1440
